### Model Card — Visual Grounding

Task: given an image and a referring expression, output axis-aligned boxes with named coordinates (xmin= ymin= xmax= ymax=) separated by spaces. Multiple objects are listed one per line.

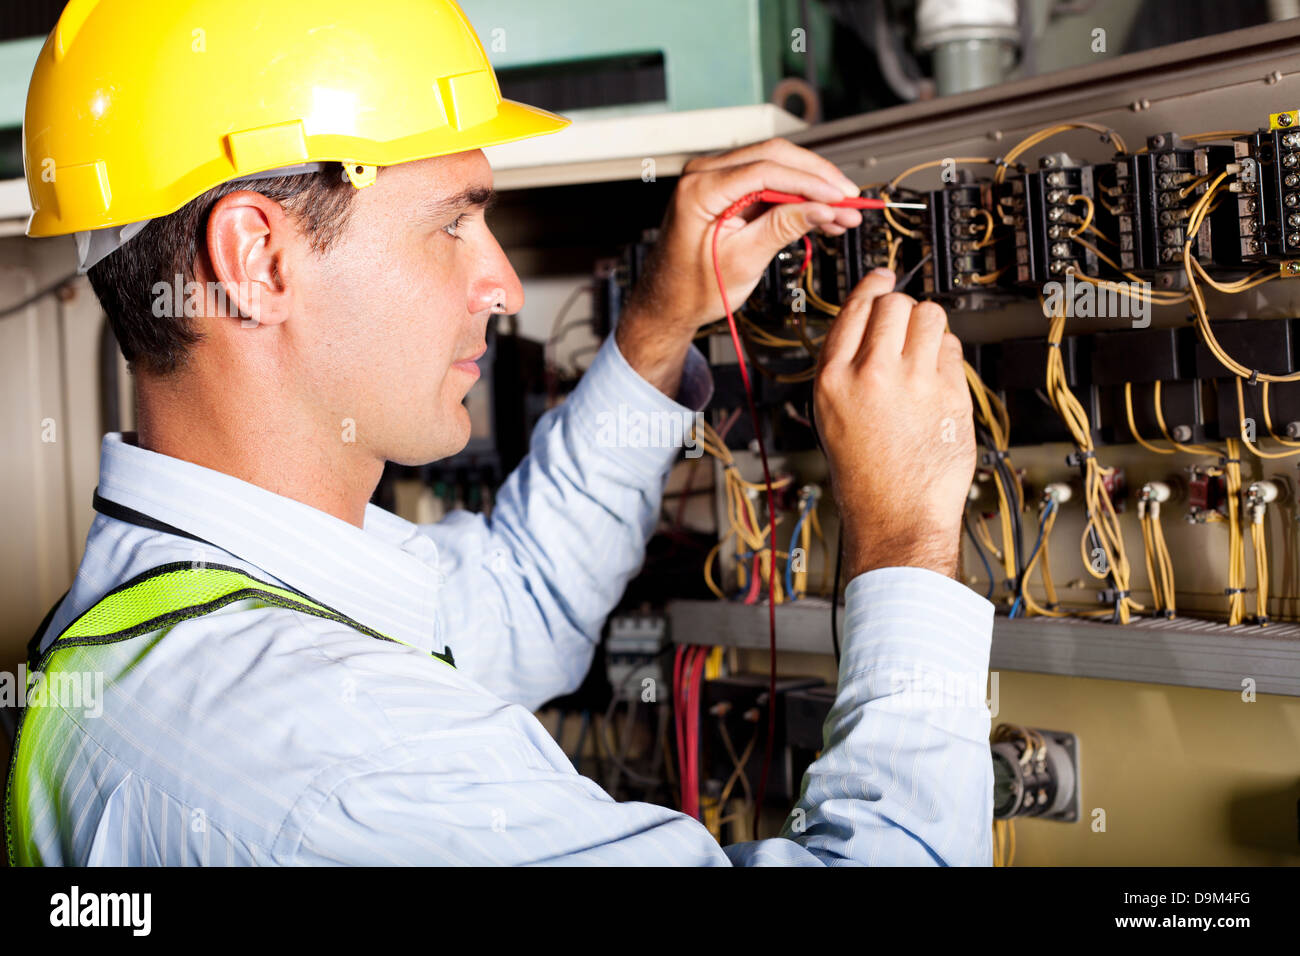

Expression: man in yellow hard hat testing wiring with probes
xmin=7 ymin=0 xmax=992 ymax=865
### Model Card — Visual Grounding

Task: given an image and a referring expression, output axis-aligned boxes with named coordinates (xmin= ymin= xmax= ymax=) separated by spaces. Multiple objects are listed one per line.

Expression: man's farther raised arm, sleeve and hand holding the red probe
xmin=424 ymin=139 xmax=862 ymax=706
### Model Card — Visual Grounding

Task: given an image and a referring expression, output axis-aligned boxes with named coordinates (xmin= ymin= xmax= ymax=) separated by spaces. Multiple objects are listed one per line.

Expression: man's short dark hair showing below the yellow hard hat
xmin=87 ymin=163 xmax=356 ymax=375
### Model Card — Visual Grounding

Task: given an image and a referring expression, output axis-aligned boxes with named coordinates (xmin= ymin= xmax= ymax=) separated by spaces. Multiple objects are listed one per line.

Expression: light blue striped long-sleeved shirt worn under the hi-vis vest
xmin=12 ymin=339 xmax=993 ymax=865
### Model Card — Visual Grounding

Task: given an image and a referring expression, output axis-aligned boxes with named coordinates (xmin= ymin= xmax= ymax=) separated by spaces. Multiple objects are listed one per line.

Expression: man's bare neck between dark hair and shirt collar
xmin=137 ymin=371 xmax=384 ymax=528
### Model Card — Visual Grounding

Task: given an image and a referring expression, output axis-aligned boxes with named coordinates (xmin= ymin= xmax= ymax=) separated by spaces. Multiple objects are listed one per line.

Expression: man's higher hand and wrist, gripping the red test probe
xmin=618 ymin=139 xmax=862 ymax=395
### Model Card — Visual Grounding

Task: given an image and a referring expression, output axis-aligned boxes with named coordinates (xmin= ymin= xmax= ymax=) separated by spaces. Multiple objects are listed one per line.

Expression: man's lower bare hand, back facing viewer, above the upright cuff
xmin=814 ymin=271 xmax=975 ymax=580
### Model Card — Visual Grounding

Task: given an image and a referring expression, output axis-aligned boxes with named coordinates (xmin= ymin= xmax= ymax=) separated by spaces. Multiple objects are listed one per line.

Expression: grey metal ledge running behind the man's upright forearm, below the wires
xmin=668 ymin=598 xmax=1300 ymax=697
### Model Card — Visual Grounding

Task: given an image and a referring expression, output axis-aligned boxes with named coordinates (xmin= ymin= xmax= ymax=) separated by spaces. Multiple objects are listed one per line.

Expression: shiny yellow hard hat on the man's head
xmin=22 ymin=0 xmax=569 ymax=243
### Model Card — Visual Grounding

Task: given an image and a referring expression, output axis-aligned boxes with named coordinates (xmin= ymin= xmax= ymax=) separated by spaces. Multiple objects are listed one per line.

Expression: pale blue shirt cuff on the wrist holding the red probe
xmin=564 ymin=336 xmax=714 ymax=477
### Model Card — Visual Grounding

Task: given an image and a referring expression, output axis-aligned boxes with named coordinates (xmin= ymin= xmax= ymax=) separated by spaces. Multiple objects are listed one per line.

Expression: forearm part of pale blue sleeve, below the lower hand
xmin=727 ymin=567 xmax=993 ymax=866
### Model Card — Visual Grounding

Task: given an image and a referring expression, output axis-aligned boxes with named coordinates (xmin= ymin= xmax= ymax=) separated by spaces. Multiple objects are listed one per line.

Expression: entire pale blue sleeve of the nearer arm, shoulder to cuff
xmin=287 ymin=568 xmax=993 ymax=866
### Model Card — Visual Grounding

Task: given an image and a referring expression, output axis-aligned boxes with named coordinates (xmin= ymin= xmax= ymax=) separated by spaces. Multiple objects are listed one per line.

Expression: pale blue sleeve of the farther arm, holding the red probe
xmin=421 ymin=336 xmax=712 ymax=709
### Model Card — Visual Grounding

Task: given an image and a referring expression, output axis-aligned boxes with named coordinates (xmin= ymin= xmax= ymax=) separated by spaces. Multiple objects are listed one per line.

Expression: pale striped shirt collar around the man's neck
xmin=99 ymin=432 xmax=442 ymax=650
